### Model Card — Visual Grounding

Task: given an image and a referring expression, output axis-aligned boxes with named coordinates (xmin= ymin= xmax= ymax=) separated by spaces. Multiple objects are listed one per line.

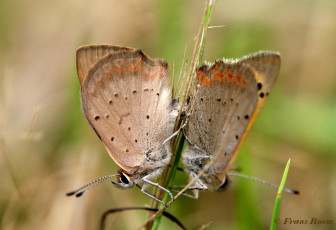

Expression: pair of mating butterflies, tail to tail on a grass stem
xmin=68 ymin=45 xmax=280 ymax=203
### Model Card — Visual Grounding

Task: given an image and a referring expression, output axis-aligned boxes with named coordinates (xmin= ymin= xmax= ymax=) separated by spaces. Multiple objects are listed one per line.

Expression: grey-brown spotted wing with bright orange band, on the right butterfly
xmin=185 ymin=53 xmax=279 ymax=187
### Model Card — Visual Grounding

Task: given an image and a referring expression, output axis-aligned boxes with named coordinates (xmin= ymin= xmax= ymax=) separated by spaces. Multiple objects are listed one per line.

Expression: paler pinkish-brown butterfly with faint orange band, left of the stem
xmin=67 ymin=45 xmax=179 ymax=203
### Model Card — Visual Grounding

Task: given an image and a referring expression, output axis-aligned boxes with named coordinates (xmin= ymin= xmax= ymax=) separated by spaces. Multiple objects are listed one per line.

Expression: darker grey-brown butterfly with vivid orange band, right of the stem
xmin=182 ymin=52 xmax=280 ymax=198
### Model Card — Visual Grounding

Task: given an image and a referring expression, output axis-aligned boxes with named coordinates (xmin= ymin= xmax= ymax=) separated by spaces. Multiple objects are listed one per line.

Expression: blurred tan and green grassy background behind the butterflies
xmin=0 ymin=0 xmax=336 ymax=230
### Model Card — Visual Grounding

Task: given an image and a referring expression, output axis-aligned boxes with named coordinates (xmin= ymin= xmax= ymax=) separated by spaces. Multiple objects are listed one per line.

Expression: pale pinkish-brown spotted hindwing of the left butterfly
xmin=77 ymin=48 xmax=175 ymax=174
